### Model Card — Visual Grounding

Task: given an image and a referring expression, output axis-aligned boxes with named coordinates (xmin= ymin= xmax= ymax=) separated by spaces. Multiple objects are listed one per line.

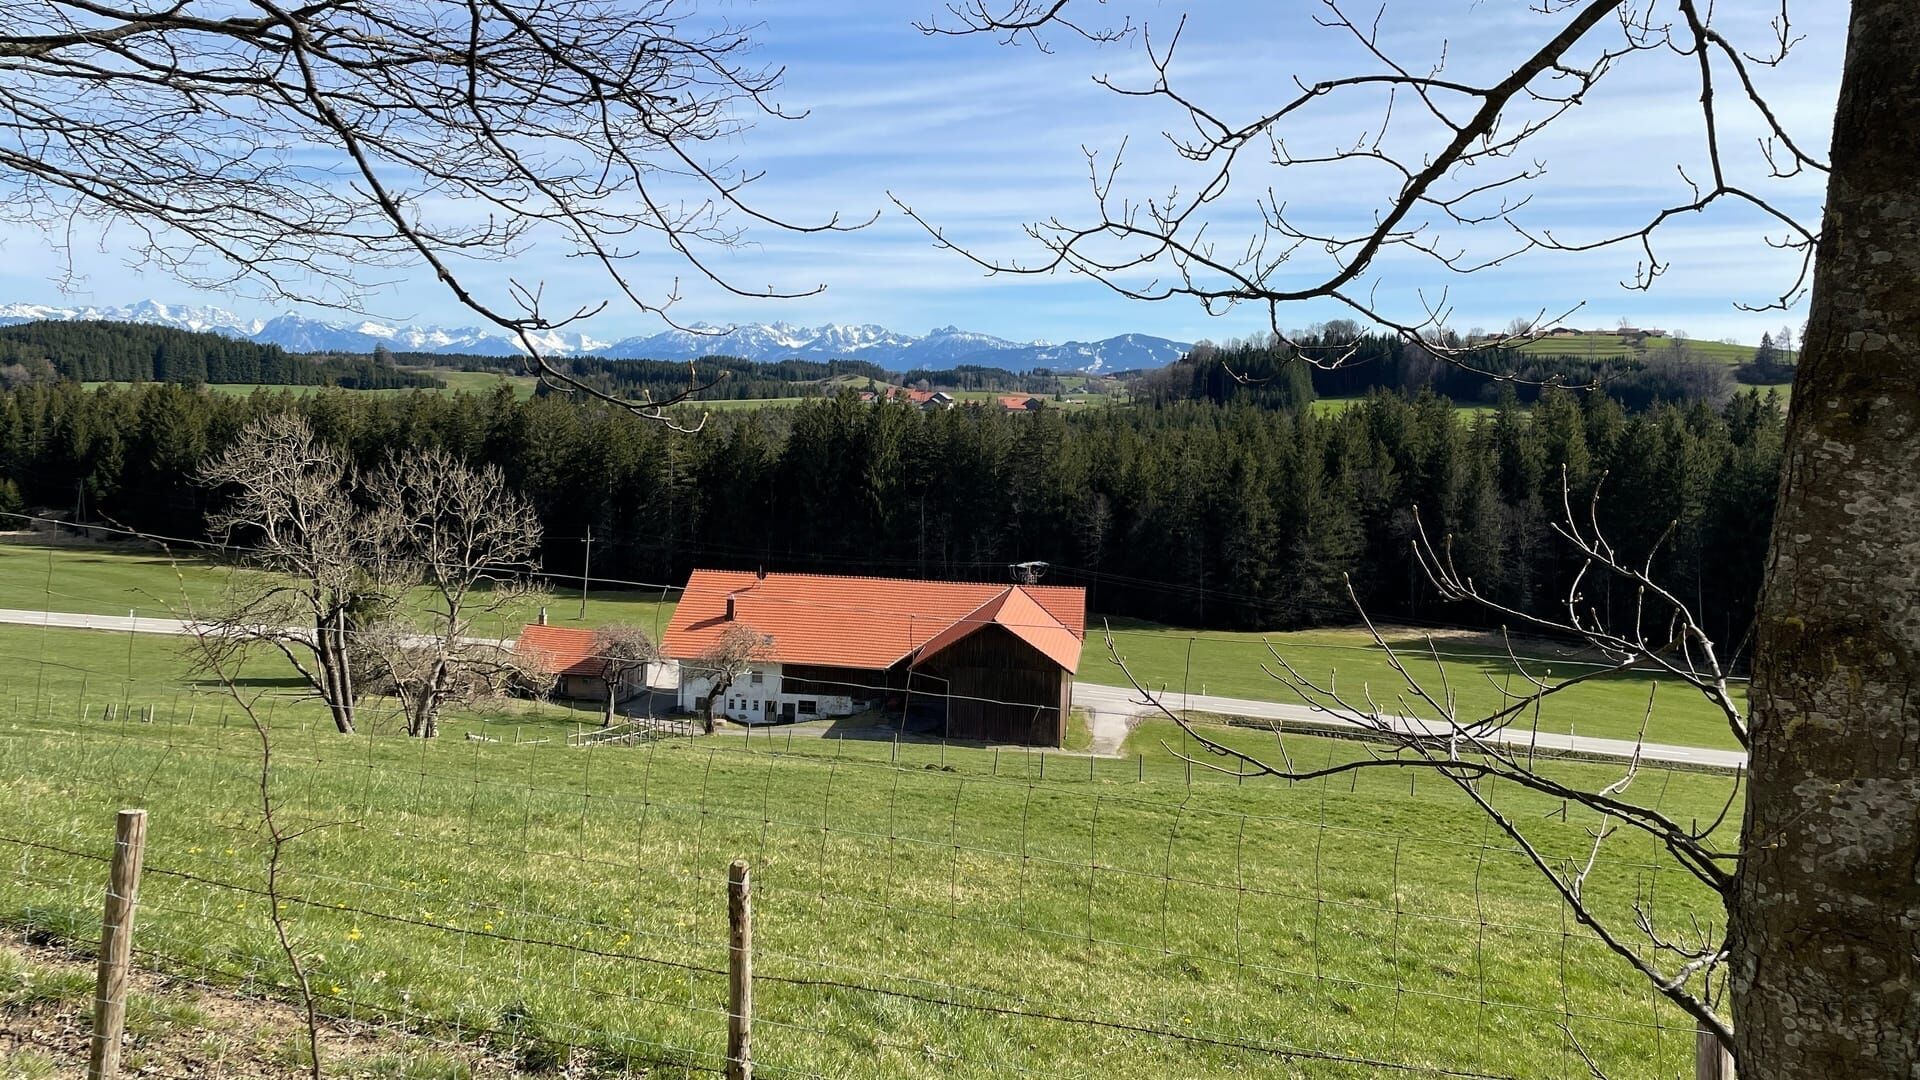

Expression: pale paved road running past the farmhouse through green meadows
xmin=0 ymin=607 xmax=1747 ymax=769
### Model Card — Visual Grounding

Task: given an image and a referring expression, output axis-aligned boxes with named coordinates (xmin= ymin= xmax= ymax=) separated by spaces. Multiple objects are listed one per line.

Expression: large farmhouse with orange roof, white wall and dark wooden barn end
xmin=662 ymin=571 xmax=1087 ymax=746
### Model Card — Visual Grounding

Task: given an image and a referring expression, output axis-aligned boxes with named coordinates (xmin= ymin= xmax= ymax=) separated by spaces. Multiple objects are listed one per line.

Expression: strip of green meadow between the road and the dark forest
xmin=0 ymin=544 xmax=1743 ymax=748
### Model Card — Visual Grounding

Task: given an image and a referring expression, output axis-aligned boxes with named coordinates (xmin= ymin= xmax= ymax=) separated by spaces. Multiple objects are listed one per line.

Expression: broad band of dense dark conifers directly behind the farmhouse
xmin=0 ymin=382 xmax=1782 ymax=648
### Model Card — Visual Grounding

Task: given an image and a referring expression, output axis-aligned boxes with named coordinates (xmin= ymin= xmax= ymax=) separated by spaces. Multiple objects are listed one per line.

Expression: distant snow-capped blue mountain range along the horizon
xmin=0 ymin=300 xmax=1190 ymax=373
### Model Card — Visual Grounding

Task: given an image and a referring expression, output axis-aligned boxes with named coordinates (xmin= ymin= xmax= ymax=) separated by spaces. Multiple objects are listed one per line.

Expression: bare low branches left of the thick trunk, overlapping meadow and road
xmin=1108 ymin=476 xmax=1749 ymax=1042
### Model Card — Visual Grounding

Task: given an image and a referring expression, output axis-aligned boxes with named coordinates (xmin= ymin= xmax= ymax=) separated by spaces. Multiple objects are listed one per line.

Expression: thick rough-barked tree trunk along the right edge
xmin=1730 ymin=0 xmax=1920 ymax=1080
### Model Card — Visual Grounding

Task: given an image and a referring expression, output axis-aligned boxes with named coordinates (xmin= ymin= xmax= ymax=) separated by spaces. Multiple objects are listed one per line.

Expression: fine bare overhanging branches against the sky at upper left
xmin=0 ymin=0 xmax=871 ymax=421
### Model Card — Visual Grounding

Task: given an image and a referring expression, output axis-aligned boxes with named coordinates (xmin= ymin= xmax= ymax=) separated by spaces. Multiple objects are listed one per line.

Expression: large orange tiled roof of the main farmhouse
xmin=662 ymin=571 xmax=1087 ymax=671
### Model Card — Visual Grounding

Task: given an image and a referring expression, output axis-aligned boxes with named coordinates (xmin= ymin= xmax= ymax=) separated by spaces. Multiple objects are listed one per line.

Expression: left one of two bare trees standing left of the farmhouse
xmin=200 ymin=413 xmax=396 ymax=732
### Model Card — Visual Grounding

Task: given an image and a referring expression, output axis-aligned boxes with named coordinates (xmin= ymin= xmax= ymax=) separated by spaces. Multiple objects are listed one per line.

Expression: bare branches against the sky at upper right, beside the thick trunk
xmin=895 ymin=0 xmax=1826 ymax=375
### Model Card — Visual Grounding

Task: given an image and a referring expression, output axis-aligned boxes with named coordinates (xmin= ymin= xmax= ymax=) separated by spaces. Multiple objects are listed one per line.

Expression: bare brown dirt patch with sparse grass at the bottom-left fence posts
xmin=0 ymin=934 xmax=529 ymax=1080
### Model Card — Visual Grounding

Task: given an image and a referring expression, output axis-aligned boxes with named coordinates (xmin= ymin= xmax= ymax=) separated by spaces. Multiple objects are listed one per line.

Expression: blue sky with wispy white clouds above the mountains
xmin=0 ymin=0 xmax=1845 ymax=342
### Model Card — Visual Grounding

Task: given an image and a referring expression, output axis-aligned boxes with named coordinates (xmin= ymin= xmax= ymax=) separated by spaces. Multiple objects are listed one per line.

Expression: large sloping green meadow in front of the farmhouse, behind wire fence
xmin=0 ymin=626 xmax=1734 ymax=1078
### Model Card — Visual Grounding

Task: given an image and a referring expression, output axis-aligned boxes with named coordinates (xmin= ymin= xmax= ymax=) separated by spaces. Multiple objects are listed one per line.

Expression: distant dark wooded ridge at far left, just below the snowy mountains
xmin=0 ymin=321 xmax=440 ymax=390
